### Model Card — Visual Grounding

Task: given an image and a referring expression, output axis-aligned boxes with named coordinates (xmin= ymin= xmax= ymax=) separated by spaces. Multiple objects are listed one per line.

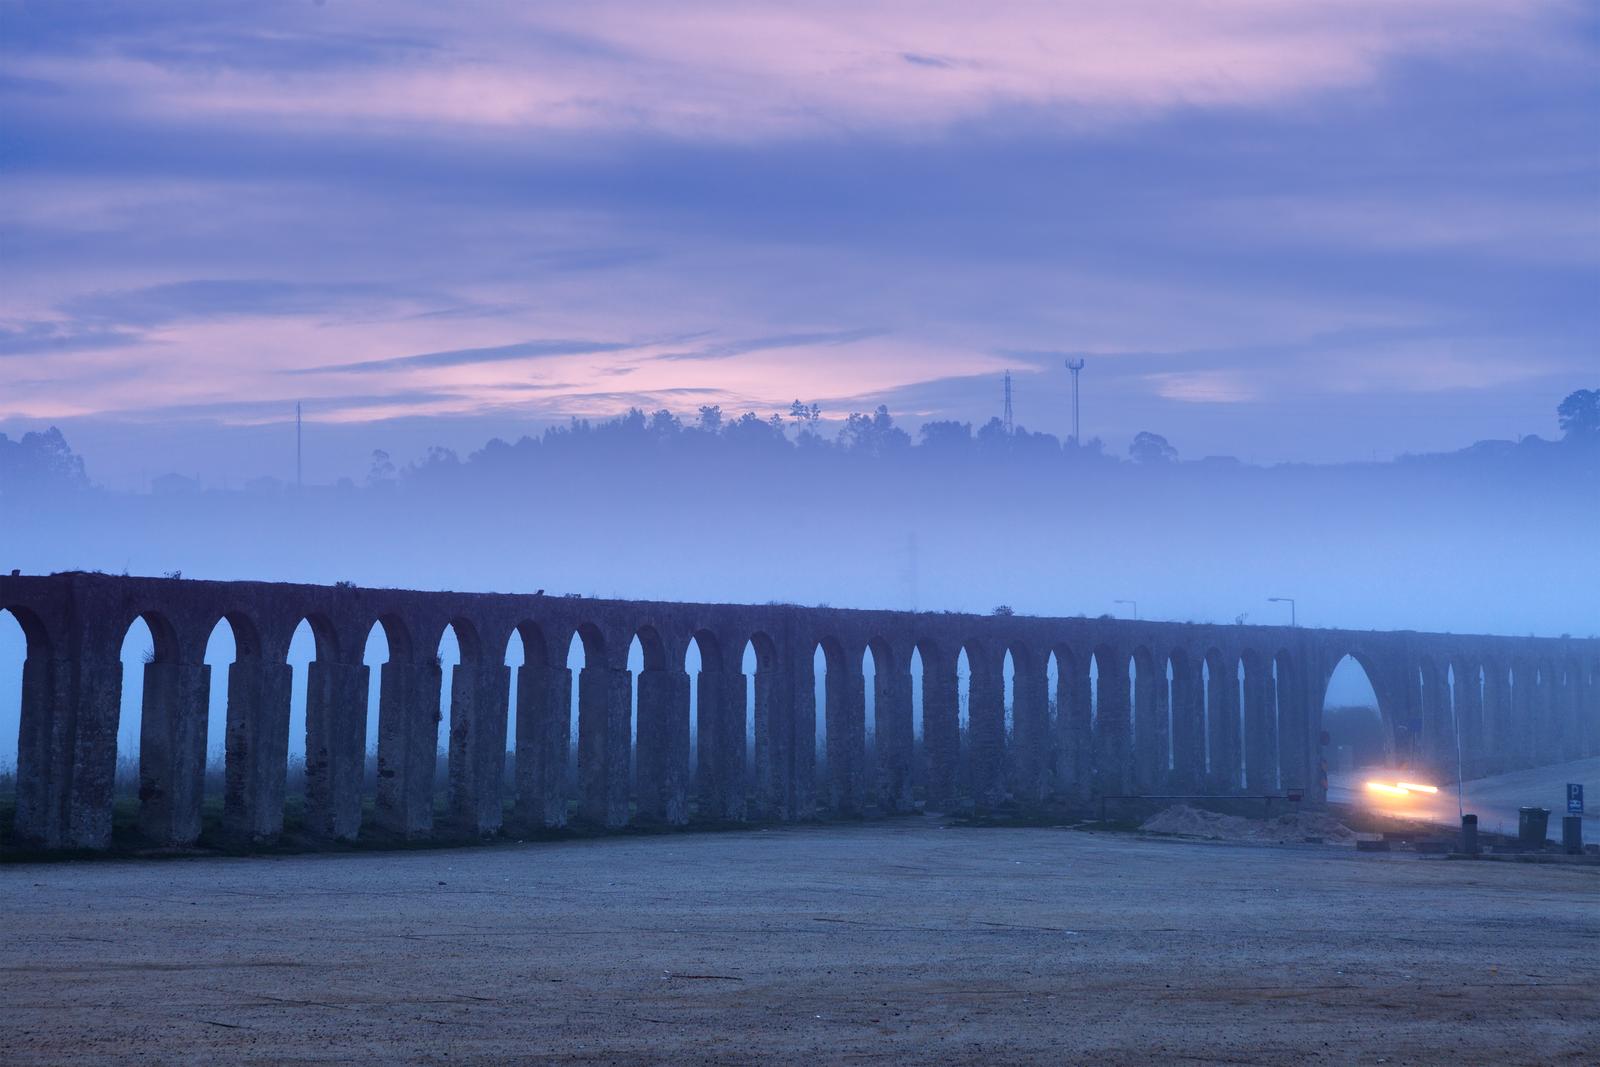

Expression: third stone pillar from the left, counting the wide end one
xmin=222 ymin=659 xmax=299 ymax=846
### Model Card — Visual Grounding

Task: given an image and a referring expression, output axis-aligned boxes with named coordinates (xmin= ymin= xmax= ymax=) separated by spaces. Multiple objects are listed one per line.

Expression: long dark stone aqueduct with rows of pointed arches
xmin=0 ymin=573 xmax=1600 ymax=848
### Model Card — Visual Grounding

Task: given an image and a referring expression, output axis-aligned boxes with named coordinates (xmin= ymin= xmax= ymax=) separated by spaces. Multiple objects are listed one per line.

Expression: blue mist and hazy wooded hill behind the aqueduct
xmin=0 ymin=396 xmax=1600 ymax=771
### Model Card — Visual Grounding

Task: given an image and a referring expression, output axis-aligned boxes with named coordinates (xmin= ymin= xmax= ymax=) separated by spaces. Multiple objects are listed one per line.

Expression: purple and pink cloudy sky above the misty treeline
xmin=0 ymin=0 xmax=1600 ymax=486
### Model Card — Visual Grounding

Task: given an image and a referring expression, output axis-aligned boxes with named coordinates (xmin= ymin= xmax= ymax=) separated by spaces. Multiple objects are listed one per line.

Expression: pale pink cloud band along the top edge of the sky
xmin=18 ymin=0 xmax=1574 ymax=139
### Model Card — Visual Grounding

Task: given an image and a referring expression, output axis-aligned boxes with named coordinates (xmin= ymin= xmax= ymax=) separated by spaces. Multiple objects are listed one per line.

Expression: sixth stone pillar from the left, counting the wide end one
xmin=450 ymin=664 xmax=510 ymax=837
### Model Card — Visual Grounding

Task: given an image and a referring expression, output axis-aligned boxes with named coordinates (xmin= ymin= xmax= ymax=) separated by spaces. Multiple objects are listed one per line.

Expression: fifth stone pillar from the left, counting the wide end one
xmin=378 ymin=659 xmax=442 ymax=838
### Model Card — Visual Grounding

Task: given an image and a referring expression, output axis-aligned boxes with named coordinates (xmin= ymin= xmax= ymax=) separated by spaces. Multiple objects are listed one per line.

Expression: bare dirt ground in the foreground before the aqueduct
xmin=0 ymin=819 xmax=1600 ymax=1064
